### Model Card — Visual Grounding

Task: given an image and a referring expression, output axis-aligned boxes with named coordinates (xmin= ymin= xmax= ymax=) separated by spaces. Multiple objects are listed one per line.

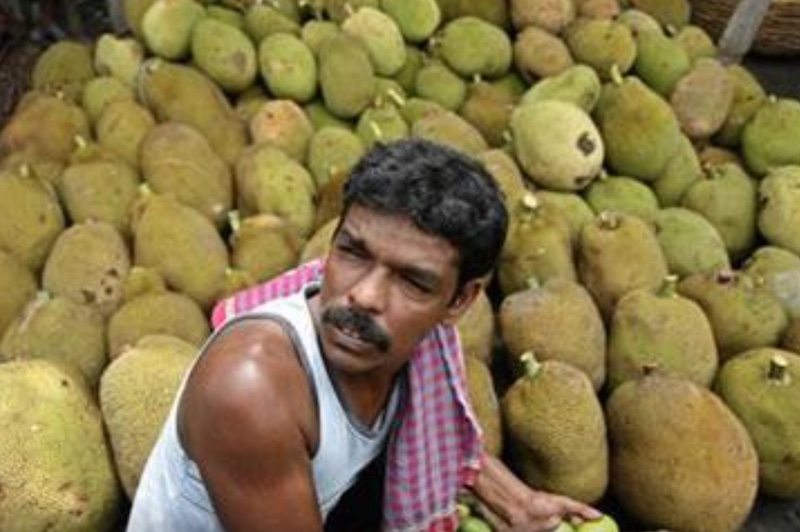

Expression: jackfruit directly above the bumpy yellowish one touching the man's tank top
xmin=107 ymin=290 xmax=211 ymax=359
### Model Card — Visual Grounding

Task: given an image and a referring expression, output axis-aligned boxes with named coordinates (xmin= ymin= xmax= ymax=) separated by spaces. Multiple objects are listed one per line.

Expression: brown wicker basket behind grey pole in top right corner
xmin=691 ymin=0 xmax=800 ymax=56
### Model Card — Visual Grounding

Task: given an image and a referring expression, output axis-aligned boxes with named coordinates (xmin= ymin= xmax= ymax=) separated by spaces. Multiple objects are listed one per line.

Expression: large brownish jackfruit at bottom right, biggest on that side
xmin=605 ymin=371 xmax=758 ymax=532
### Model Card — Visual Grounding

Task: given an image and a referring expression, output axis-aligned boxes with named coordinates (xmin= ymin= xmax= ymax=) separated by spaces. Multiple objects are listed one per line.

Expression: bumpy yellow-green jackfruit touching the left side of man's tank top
xmin=99 ymin=335 xmax=197 ymax=500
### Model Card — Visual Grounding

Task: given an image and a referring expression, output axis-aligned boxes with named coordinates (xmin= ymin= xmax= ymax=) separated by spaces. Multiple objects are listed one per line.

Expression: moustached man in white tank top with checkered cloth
xmin=129 ymin=140 xmax=599 ymax=532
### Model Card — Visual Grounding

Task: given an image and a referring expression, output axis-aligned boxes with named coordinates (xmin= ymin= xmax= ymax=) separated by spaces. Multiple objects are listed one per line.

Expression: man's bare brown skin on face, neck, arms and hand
xmin=178 ymin=204 xmax=599 ymax=532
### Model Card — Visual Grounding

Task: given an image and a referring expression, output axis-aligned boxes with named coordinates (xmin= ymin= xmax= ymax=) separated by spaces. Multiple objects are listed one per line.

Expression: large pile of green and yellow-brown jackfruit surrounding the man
xmin=0 ymin=0 xmax=800 ymax=532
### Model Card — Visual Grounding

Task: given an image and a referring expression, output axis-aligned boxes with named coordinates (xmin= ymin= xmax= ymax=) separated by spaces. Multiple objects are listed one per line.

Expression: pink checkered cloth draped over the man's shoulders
xmin=211 ymin=261 xmax=482 ymax=532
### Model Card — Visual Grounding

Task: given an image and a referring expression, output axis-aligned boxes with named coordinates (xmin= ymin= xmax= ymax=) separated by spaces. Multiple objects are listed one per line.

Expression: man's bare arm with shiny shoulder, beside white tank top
xmin=179 ymin=322 xmax=322 ymax=532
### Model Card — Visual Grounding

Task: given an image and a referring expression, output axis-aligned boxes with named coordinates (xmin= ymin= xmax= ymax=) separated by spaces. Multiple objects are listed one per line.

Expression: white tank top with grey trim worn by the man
xmin=128 ymin=286 xmax=402 ymax=532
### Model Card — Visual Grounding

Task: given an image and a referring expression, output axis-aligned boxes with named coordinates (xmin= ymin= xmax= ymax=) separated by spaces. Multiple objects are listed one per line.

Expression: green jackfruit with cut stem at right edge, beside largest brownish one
xmin=714 ymin=348 xmax=800 ymax=499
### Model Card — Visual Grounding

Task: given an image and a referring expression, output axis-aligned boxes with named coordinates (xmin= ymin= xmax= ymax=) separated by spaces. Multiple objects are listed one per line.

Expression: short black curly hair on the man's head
xmin=342 ymin=138 xmax=508 ymax=287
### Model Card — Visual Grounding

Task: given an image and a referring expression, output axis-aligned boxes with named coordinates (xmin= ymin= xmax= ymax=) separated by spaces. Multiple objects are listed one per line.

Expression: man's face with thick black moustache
xmin=316 ymin=205 xmax=480 ymax=374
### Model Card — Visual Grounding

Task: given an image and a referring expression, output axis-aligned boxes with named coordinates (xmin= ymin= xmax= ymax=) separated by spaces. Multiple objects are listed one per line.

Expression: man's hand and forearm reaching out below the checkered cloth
xmin=472 ymin=454 xmax=603 ymax=532
